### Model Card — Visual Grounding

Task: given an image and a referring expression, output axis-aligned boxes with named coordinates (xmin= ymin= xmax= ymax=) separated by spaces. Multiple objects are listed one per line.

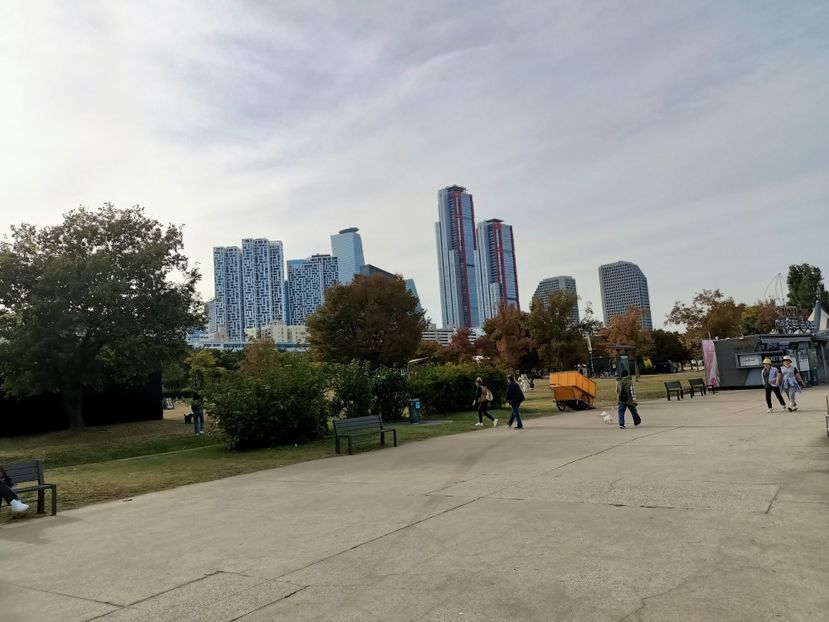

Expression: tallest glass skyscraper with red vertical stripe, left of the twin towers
xmin=435 ymin=186 xmax=481 ymax=328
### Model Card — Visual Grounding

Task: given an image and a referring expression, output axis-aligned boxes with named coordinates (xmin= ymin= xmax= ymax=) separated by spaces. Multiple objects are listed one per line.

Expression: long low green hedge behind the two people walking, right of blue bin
xmin=409 ymin=363 xmax=507 ymax=413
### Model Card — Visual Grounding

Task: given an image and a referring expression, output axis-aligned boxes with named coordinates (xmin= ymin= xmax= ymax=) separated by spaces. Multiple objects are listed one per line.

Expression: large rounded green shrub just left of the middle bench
xmin=206 ymin=351 xmax=328 ymax=449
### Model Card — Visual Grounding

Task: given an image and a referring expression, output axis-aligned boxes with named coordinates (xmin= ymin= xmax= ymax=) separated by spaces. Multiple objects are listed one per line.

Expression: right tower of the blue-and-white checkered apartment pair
xmin=242 ymin=238 xmax=285 ymax=328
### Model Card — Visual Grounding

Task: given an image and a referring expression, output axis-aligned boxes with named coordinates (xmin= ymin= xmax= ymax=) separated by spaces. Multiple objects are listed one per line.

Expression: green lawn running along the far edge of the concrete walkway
xmin=0 ymin=372 xmax=702 ymax=520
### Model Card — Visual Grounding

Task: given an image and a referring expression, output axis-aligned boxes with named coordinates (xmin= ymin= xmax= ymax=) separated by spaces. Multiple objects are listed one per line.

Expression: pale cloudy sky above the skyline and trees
xmin=0 ymin=0 xmax=829 ymax=328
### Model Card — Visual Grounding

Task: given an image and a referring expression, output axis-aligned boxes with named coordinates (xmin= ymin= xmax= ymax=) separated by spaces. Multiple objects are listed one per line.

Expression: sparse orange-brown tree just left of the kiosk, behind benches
xmin=666 ymin=289 xmax=746 ymax=356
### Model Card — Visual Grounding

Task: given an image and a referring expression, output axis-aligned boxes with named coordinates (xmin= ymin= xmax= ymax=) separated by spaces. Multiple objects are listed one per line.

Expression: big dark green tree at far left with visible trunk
xmin=0 ymin=204 xmax=204 ymax=429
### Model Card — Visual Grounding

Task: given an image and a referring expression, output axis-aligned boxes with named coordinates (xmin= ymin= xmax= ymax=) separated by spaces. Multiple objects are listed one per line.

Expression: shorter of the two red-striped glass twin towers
xmin=475 ymin=218 xmax=518 ymax=324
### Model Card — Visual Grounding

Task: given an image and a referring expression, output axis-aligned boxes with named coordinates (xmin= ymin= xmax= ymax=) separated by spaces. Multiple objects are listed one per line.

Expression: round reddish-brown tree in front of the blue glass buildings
xmin=305 ymin=274 xmax=426 ymax=366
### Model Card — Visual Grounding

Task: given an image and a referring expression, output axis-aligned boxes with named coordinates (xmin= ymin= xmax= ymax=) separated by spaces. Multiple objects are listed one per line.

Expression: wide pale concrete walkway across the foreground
xmin=0 ymin=387 xmax=829 ymax=622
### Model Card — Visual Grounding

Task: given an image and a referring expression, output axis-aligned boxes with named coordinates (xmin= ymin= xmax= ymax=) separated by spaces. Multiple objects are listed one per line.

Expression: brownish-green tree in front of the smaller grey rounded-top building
xmin=529 ymin=291 xmax=595 ymax=369
